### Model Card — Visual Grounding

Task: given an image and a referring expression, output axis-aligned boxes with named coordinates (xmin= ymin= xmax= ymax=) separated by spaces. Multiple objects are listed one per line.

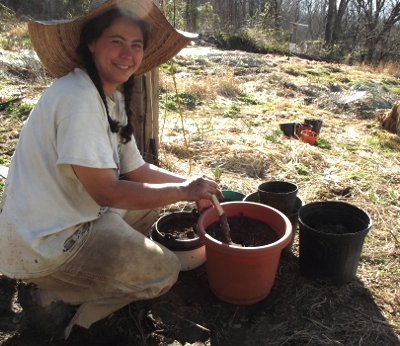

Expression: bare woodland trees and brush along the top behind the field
xmin=0 ymin=0 xmax=400 ymax=66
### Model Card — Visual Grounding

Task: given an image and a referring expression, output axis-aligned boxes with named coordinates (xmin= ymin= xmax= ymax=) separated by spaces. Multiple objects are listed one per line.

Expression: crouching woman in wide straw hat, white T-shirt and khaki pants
xmin=0 ymin=0 xmax=222 ymax=338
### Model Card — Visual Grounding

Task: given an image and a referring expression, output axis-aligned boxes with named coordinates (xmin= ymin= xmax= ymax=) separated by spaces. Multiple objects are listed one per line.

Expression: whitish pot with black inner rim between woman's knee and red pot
xmin=149 ymin=212 xmax=206 ymax=271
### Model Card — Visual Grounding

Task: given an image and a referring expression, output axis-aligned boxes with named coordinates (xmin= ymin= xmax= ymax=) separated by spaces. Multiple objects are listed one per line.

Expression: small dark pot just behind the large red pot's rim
xmin=258 ymin=181 xmax=298 ymax=215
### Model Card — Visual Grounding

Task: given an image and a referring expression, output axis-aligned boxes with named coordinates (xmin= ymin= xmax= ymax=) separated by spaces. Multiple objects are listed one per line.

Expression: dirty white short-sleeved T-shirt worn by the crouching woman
xmin=0 ymin=69 xmax=145 ymax=278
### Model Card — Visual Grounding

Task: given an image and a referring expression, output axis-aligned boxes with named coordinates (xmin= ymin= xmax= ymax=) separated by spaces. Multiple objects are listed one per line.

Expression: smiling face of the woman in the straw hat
xmin=88 ymin=17 xmax=143 ymax=95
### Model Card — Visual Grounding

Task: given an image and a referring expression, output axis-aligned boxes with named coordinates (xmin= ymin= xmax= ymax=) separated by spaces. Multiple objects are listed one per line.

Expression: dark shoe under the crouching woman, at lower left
xmin=18 ymin=282 xmax=78 ymax=335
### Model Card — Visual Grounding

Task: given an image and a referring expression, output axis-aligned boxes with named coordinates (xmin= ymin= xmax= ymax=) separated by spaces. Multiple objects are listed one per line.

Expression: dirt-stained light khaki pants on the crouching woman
xmin=23 ymin=208 xmax=180 ymax=338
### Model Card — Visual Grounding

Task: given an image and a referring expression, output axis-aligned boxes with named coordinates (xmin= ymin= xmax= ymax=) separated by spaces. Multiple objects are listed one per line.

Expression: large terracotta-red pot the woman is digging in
xmin=197 ymin=202 xmax=292 ymax=305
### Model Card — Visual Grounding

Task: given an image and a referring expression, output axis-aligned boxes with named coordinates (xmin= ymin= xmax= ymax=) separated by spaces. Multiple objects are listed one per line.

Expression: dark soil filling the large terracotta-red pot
xmin=206 ymin=216 xmax=279 ymax=247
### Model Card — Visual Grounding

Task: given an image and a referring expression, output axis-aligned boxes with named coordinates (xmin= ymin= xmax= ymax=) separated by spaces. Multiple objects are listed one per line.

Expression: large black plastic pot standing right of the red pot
xmin=299 ymin=201 xmax=372 ymax=285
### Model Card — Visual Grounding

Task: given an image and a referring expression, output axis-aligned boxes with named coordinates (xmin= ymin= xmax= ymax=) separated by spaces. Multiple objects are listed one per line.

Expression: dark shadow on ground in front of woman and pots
xmin=0 ymin=255 xmax=400 ymax=346
